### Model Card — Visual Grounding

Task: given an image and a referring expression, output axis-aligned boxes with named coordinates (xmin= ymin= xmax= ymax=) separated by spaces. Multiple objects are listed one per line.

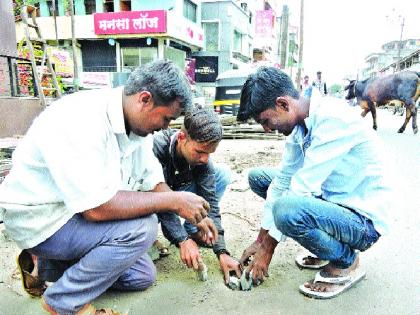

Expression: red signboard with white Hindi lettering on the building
xmin=93 ymin=10 xmax=166 ymax=35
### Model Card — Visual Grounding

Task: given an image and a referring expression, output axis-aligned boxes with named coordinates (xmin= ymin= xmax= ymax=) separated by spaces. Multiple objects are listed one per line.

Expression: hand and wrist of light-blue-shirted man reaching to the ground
xmin=245 ymin=234 xmax=278 ymax=284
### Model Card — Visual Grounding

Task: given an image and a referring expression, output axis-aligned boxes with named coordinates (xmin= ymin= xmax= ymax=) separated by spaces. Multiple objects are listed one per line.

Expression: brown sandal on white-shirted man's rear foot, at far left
xmin=16 ymin=249 xmax=47 ymax=297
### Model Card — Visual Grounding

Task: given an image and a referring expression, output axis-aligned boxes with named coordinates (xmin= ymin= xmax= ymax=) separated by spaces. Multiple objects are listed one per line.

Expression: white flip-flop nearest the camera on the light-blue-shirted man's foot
xmin=299 ymin=269 xmax=366 ymax=300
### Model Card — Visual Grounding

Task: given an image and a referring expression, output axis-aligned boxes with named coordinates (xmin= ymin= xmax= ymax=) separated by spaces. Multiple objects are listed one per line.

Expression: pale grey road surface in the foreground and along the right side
xmin=0 ymin=110 xmax=420 ymax=315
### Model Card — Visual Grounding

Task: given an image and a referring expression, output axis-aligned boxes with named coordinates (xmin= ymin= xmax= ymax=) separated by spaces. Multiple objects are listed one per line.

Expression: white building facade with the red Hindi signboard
xmin=17 ymin=0 xmax=204 ymax=87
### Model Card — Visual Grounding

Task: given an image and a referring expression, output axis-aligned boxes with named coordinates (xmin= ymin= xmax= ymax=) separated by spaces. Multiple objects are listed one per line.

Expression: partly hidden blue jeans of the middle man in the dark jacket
xmin=177 ymin=164 xmax=231 ymax=235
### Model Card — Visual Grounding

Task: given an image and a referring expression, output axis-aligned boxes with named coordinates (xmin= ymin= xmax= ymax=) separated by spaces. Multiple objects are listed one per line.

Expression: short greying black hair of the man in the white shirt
xmin=124 ymin=60 xmax=192 ymax=110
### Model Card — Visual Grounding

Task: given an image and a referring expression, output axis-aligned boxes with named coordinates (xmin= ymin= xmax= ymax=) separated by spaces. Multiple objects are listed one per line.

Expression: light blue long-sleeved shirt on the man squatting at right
xmin=261 ymin=90 xmax=393 ymax=241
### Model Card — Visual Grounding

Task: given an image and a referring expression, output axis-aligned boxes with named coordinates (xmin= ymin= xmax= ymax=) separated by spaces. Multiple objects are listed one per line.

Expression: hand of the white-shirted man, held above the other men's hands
xmin=176 ymin=191 xmax=210 ymax=225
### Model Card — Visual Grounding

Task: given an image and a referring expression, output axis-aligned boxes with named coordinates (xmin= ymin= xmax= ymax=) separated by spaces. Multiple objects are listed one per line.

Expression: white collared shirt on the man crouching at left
xmin=0 ymin=88 xmax=164 ymax=248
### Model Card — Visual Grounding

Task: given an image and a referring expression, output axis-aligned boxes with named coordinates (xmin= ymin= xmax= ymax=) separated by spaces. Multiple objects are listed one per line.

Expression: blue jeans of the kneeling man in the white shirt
xmin=29 ymin=214 xmax=157 ymax=315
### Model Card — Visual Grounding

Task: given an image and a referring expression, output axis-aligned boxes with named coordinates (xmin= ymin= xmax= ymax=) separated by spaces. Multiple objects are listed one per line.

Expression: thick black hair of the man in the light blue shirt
xmin=237 ymin=67 xmax=299 ymax=121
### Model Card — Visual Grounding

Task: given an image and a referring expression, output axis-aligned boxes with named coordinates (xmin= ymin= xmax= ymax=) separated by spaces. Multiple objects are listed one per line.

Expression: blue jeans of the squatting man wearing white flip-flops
xmin=249 ymin=168 xmax=380 ymax=269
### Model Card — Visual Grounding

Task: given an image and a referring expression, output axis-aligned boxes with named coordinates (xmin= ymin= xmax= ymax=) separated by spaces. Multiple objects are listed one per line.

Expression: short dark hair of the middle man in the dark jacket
xmin=182 ymin=106 xmax=223 ymax=143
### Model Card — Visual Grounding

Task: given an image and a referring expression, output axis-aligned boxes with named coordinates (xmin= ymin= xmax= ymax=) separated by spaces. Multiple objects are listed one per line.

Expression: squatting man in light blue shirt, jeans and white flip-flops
xmin=238 ymin=68 xmax=391 ymax=298
